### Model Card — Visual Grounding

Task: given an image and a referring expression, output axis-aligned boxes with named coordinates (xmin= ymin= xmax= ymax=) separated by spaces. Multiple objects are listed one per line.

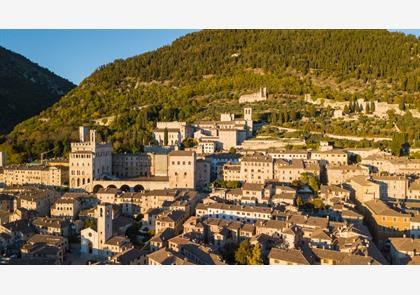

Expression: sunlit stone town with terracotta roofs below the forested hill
xmin=0 ymin=93 xmax=420 ymax=265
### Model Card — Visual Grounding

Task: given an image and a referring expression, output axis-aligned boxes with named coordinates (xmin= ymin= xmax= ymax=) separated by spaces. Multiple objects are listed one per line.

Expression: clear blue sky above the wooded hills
xmin=0 ymin=29 xmax=420 ymax=84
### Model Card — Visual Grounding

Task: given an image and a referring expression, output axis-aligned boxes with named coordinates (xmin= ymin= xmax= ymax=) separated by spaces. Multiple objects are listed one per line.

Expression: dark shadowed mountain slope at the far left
xmin=0 ymin=46 xmax=75 ymax=134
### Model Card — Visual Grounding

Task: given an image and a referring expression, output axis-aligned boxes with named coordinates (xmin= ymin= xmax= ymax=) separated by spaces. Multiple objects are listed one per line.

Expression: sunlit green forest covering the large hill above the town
xmin=2 ymin=30 xmax=420 ymax=162
